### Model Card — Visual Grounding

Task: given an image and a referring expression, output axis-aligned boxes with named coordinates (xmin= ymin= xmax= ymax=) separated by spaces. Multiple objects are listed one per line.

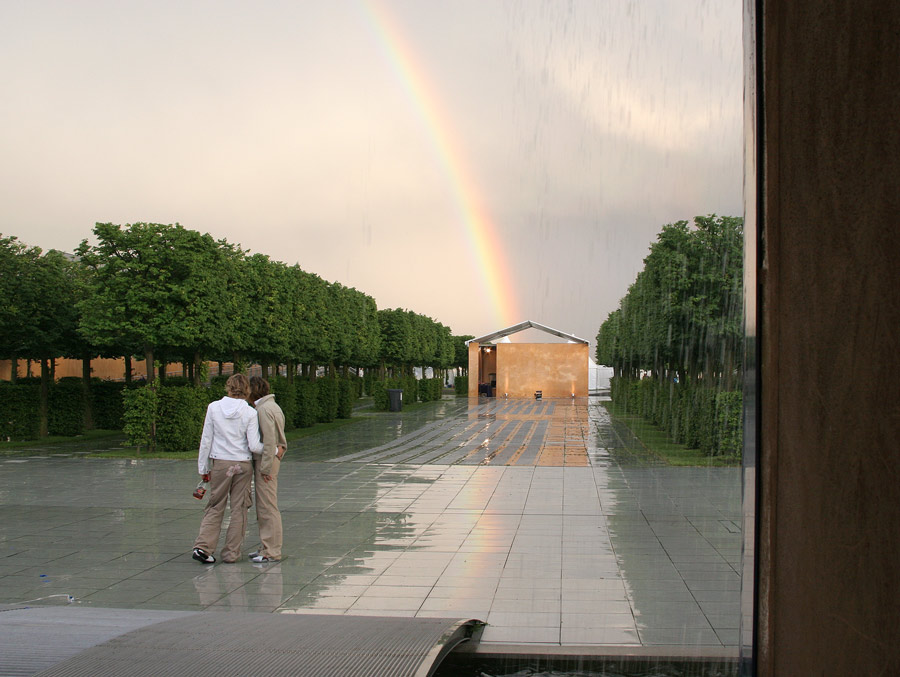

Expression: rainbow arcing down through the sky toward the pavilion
xmin=363 ymin=0 xmax=522 ymax=328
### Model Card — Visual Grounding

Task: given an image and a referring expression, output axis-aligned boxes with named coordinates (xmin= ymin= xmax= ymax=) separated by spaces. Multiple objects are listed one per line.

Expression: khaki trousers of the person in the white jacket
xmin=194 ymin=458 xmax=253 ymax=562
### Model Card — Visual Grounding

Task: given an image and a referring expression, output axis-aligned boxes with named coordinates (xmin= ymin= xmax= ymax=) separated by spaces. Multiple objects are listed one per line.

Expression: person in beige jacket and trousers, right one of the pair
xmin=250 ymin=376 xmax=287 ymax=564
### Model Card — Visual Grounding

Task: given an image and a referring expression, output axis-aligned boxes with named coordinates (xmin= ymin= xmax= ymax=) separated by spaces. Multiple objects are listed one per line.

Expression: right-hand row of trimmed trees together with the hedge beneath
xmin=597 ymin=215 xmax=743 ymax=454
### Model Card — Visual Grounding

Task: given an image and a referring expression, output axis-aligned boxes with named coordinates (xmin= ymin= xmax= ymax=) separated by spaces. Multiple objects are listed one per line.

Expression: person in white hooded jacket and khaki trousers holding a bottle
xmin=191 ymin=374 xmax=263 ymax=564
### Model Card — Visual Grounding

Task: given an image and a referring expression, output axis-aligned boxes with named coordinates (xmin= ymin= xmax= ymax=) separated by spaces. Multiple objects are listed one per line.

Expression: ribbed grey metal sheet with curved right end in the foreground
xmin=26 ymin=612 xmax=483 ymax=677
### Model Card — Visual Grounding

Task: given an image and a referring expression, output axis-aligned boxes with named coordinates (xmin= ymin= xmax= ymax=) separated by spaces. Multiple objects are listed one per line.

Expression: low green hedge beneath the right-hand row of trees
xmin=610 ymin=377 xmax=743 ymax=456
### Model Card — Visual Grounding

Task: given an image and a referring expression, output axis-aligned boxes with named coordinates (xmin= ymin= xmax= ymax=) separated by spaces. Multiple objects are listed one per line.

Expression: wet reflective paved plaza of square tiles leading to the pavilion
xmin=0 ymin=398 xmax=741 ymax=648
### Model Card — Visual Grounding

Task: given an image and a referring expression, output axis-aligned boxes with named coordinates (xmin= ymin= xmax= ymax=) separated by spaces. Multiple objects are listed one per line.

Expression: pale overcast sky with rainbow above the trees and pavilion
xmin=0 ymin=0 xmax=742 ymax=341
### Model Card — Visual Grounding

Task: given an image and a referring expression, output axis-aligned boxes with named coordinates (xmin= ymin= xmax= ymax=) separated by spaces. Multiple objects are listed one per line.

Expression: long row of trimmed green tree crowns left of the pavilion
xmin=0 ymin=223 xmax=468 ymax=430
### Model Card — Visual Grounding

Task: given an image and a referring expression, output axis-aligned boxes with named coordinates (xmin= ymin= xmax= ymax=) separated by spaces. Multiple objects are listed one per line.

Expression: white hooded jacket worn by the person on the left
xmin=197 ymin=397 xmax=263 ymax=475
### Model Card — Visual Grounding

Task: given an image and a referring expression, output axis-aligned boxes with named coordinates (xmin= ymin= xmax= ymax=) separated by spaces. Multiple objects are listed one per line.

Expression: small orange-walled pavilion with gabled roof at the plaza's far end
xmin=466 ymin=320 xmax=590 ymax=398
